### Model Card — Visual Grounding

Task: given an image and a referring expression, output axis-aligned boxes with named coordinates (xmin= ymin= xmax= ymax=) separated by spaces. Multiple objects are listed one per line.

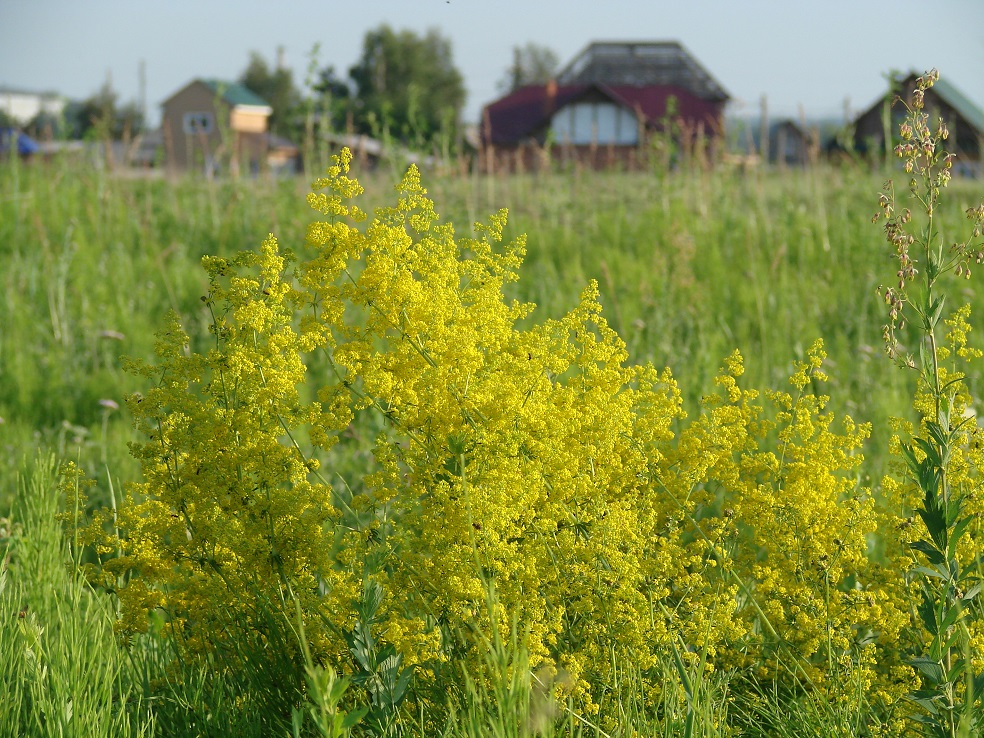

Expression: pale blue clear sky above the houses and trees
xmin=0 ymin=0 xmax=984 ymax=124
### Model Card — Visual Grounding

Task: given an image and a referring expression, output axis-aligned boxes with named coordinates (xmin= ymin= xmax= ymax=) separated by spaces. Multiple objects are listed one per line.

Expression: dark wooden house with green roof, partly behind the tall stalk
xmin=853 ymin=72 xmax=984 ymax=176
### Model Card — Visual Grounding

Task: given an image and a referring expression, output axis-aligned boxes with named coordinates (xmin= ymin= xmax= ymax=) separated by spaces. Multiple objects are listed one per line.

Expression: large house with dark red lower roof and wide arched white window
xmin=481 ymin=41 xmax=730 ymax=170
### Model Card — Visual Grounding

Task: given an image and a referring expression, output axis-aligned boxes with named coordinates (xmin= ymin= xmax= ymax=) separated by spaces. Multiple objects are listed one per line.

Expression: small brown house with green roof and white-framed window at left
xmin=161 ymin=79 xmax=273 ymax=173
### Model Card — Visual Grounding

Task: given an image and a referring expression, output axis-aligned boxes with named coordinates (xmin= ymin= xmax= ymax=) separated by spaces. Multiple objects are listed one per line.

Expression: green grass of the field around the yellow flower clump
xmin=0 ymin=152 xmax=984 ymax=738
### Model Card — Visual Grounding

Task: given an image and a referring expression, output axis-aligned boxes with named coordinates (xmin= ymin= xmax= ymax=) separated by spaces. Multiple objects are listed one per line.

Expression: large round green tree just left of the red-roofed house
xmin=349 ymin=24 xmax=465 ymax=143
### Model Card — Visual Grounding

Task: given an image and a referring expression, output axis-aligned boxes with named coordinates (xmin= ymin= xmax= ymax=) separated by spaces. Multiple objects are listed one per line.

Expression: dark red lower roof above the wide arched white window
xmin=482 ymin=84 xmax=722 ymax=145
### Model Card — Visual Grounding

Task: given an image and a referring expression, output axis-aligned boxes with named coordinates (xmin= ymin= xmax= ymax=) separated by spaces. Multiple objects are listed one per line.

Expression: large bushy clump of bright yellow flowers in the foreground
xmin=67 ymin=151 xmax=899 ymax=708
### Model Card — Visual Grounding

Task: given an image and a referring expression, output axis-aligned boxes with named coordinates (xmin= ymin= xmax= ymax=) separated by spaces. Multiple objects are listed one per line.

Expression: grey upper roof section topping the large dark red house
xmin=557 ymin=41 xmax=731 ymax=102
